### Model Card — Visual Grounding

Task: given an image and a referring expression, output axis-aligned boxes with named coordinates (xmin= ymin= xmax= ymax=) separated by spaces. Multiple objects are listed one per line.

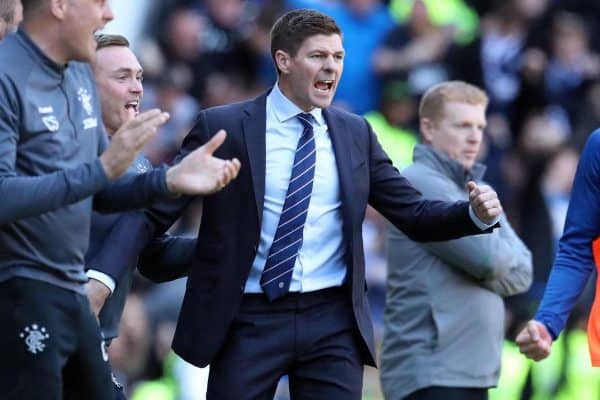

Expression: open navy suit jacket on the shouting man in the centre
xmin=149 ymin=94 xmax=482 ymax=366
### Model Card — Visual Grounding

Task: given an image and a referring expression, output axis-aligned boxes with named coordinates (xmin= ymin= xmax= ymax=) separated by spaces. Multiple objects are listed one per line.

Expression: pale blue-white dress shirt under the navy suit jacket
xmin=245 ymin=84 xmax=346 ymax=293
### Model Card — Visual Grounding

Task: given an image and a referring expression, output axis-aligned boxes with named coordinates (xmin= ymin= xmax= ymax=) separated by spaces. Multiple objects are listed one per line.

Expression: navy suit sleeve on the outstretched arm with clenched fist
xmin=363 ymin=120 xmax=492 ymax=242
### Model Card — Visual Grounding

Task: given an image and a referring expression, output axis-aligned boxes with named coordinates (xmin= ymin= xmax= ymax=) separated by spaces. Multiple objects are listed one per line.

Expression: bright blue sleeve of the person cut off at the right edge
xmin=534 ymin=130 xmax=600 ymax=338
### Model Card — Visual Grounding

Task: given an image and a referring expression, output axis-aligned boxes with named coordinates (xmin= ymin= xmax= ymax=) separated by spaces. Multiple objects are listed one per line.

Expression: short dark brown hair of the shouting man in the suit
xmin=271 ymin=9 xmax=342 ymax=70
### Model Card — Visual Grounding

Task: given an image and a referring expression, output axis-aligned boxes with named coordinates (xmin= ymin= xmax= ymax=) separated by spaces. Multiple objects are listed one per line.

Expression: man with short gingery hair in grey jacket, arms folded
xmin=381 ymin=81 xmax=532 ymax=400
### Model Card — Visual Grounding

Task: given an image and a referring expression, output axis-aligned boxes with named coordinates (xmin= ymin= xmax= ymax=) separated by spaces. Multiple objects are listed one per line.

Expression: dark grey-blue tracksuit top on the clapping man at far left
xmin=0 ymin=30 xmax=169 ymax=294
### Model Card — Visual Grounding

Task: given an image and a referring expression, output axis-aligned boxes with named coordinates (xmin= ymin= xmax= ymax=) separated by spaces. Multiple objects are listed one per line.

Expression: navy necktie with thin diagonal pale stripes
xmin=260 ymin=113 xmax=316 ymax=301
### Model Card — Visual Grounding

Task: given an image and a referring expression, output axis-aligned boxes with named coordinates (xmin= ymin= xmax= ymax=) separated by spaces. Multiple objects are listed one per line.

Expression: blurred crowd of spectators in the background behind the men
xmin=110 ymin=0 xmax=600 ymax=400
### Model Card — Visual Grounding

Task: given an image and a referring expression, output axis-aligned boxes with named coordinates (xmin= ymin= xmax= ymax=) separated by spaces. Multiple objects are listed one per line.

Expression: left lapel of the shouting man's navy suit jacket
xmin=242 ymin=93 xmax=267 ymax=228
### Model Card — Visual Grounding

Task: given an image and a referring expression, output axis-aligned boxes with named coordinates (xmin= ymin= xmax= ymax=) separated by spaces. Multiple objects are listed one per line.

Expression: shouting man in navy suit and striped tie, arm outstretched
xmin=144 ymin=10 xmax=502 ymax=400
